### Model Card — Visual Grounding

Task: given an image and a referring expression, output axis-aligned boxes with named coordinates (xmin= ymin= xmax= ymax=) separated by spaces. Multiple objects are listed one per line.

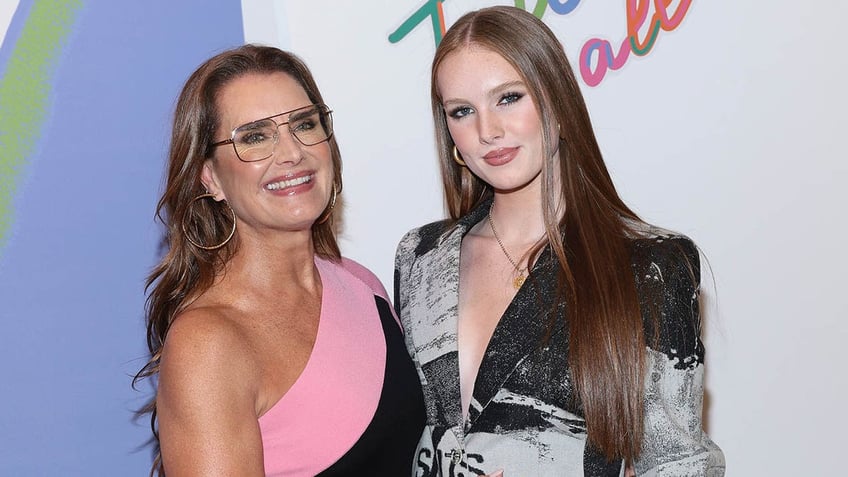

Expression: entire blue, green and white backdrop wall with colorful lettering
xmin=0 ymin=0 xmax=848 ymax=476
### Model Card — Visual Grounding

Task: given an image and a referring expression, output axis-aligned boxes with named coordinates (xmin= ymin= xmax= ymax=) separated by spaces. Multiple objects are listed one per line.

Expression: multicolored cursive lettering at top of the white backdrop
xmin=389 ymin=0 xmax=692 ymax=86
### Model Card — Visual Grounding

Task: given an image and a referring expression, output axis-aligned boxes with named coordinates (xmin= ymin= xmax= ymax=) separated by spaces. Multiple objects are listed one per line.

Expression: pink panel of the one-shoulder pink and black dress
xmin=259 ymin=259 xmax=386 ymax=476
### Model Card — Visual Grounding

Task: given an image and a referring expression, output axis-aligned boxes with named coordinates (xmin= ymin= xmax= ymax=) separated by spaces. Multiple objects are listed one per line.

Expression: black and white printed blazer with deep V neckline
xmin=395 ymin=201 xmax=724 ymax=477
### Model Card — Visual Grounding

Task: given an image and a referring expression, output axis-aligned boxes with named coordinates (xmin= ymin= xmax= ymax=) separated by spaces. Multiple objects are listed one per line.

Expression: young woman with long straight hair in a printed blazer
xmin=395 ymin=7 xmax=724 ymax=477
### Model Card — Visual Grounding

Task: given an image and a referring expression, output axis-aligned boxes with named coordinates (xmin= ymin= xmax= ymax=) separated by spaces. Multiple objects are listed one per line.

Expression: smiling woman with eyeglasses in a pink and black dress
xmin=136 ymin=45 xmax=424 ymax=477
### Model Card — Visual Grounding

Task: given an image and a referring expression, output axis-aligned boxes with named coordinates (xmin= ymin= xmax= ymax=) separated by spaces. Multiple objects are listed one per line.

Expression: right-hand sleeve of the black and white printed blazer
xmin=634 ymin=236 xmax=725 ymax=477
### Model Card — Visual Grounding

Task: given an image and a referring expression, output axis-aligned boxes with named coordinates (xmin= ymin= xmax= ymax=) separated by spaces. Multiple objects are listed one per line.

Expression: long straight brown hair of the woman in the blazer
xmin=438 ymin=6 xmax=646 ymax=462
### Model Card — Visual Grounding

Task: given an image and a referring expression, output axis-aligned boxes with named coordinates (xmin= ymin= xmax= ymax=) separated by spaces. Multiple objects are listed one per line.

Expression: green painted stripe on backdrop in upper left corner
xmin=0 ymin=0 xmax=83 ymax=251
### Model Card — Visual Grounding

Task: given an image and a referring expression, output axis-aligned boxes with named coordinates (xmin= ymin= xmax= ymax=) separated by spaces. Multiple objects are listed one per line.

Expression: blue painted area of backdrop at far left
xmin=0 ymin=0 xmax=244 ymax=476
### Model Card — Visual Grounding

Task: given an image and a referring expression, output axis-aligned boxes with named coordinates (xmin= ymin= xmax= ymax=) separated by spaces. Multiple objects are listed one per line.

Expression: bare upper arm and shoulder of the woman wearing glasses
xmin=156 ymin=306 xmax=262 ymax=476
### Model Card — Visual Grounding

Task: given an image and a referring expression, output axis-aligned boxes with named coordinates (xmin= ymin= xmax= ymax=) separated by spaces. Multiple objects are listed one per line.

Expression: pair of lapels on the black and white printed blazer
xmin=400 ymin=199 xmax=563 ymax=427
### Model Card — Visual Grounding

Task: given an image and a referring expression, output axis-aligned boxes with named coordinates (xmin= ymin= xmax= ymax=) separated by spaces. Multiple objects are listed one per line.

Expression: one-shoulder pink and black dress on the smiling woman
xmin=259 ymin=258 xmax=425 ymax=476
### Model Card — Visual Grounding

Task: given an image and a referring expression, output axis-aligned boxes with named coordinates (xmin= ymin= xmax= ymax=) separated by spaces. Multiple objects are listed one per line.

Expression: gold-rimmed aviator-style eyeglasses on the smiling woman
xmin=212 ymin=104 xmax=333 ymax=162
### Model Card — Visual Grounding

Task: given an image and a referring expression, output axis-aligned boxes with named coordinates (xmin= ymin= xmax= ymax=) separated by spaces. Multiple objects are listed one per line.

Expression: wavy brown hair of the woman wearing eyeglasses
xmin=133 ymin=45 xmax=342 ymax=475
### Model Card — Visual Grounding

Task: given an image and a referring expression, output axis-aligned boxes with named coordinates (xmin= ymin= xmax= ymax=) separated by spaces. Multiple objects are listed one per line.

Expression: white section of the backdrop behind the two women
xmin=242 ymin=0 xmax=848 ymax=476
